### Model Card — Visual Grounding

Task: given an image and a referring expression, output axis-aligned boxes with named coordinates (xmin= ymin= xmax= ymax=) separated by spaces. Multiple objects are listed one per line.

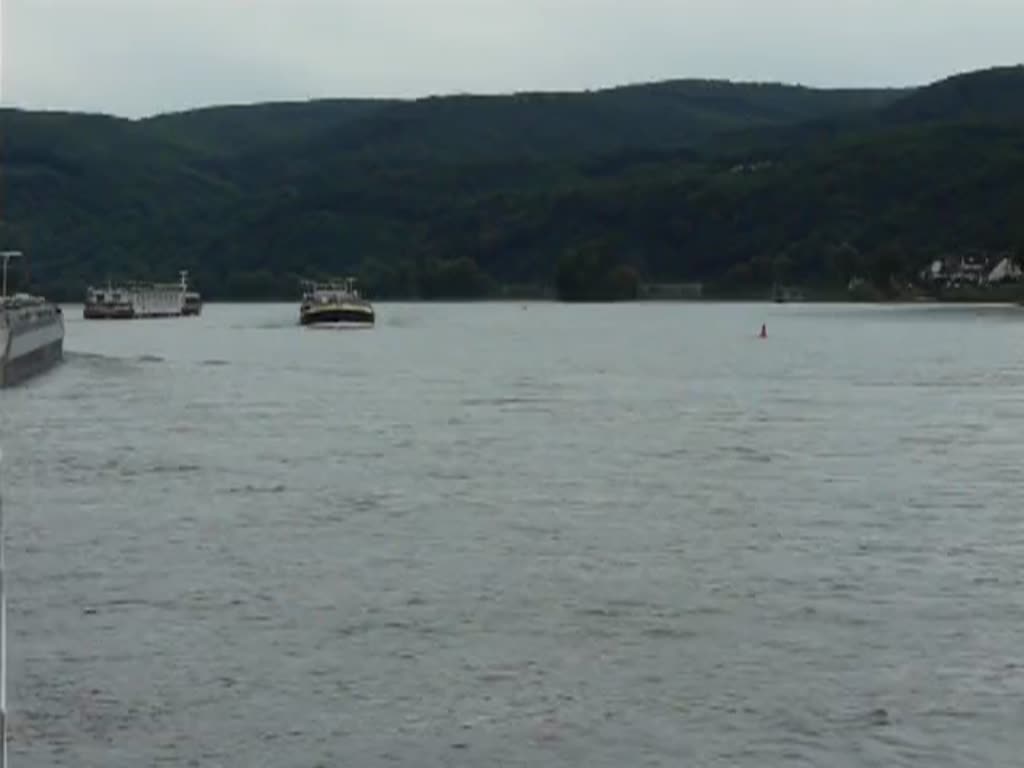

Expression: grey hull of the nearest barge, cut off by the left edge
xmin=0 ymin=252 xmax=65 ymax=387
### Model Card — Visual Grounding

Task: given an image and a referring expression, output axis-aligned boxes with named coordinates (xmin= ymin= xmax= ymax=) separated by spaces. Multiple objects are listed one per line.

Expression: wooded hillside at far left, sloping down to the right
xmin=0 ymin=110 xmax=240 ymax=285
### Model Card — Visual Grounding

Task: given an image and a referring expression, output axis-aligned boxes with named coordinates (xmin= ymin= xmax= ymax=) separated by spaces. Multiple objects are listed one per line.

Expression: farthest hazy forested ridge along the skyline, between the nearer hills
xmin=141 ymin=80 xmax=903 ymax=161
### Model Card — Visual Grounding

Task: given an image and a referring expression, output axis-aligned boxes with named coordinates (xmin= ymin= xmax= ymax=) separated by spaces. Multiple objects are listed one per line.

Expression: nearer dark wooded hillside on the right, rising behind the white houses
xmin=436 ymin=125 xmax=1024 ymax=292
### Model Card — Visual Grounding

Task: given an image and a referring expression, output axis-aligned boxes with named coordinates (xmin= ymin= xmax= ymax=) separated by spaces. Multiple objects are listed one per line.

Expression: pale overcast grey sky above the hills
xmin=0 ymin=0 xmax=1024 ymax=117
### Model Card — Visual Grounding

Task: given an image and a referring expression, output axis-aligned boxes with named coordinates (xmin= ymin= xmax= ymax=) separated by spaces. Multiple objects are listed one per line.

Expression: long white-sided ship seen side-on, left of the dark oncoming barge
xmin=82 ymin=271 xmax=202 ymax=319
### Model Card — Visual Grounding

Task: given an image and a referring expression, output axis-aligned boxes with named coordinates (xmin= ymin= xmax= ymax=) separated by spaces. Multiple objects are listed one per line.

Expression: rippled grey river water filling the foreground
xmin=0 ymin=303 xmax=1024 ymax=768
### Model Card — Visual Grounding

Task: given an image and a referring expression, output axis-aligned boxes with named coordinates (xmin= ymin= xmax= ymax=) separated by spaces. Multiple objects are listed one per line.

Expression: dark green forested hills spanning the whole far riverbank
xmin=0 ymin=68 xmax=1024 ymax=300
